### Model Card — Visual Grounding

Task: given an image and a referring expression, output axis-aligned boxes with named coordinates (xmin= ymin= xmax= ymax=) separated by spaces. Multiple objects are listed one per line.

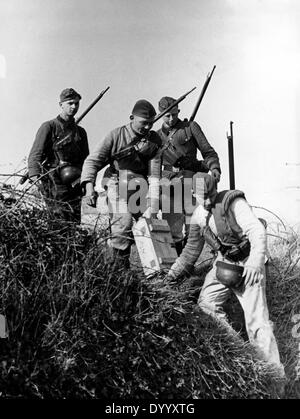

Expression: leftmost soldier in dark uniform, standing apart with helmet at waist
xmin=28 ymin=88 xmax=89 ymax=223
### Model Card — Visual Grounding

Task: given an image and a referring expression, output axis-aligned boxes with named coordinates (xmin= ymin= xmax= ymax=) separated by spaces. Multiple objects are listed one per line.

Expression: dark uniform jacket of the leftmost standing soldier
xmin=28 ymin=116 xmax=89 ymax=177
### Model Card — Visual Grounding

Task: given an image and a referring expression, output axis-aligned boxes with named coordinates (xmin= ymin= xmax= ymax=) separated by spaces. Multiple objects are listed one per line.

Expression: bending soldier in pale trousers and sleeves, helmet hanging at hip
xmin=167 ymin=174 xmax=285 ymax=378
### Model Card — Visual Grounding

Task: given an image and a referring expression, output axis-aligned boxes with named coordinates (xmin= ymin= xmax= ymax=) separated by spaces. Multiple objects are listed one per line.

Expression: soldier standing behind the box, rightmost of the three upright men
xmin=157 ymin=96 xmax=221 ymax=254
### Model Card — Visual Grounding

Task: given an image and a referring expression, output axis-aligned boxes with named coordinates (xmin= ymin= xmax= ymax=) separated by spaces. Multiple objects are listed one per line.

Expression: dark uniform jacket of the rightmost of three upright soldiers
xmin=157 ymin=119 xmax=221 ymax=173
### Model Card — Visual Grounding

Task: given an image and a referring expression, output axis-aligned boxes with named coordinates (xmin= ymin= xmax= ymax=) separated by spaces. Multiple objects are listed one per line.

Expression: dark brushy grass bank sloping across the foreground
xmin=0 ymin=197 xmax=286 ymax=399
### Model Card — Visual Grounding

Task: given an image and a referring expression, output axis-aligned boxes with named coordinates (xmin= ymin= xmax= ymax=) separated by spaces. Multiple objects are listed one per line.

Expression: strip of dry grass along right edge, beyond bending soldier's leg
xmin=267 ymin=229 xmax=300 ymax=399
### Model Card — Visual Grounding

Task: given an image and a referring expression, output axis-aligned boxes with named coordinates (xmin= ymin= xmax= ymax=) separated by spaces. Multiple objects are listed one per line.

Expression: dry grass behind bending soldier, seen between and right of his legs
xmin=190 ymin=223 xmax=300 ymax=399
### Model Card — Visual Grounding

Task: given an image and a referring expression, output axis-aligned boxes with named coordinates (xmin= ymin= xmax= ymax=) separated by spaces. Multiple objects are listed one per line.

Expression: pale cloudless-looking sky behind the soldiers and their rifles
xmin=0 ymin=0 xmax=300 ymax=228
